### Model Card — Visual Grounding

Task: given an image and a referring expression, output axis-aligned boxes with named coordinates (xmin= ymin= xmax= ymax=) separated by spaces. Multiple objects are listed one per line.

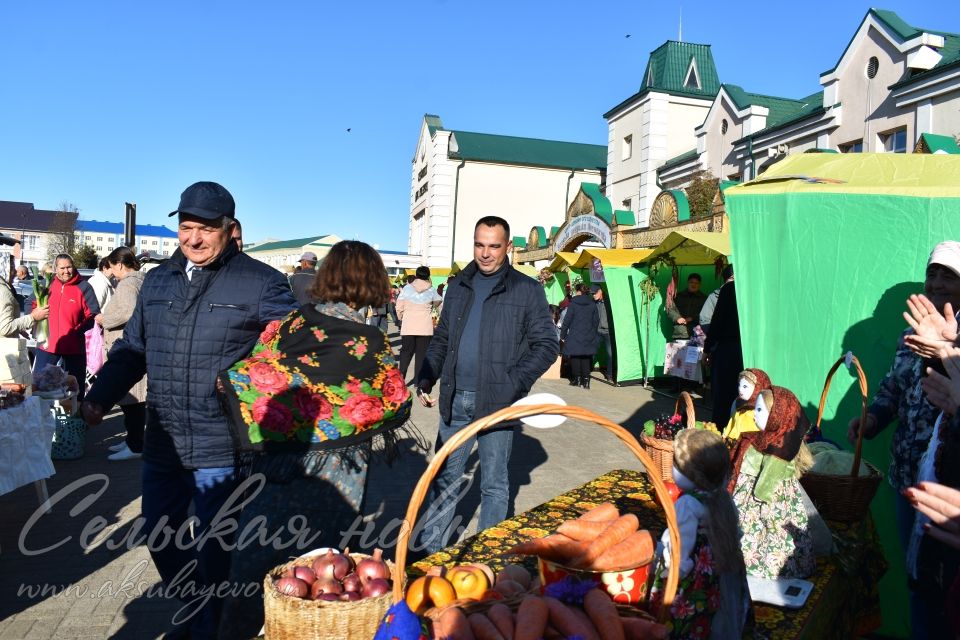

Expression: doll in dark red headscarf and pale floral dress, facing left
xmin=733 ymin=386 xmax=816 ymax=578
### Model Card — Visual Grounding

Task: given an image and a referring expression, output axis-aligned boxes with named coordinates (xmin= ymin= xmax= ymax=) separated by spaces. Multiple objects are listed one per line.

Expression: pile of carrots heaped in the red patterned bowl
xmin=508 ymin=502 xmax=654 ymax=571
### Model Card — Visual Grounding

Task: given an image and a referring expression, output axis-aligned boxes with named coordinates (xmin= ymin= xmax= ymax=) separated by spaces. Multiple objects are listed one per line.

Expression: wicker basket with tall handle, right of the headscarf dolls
xmin=800 ymin=355 xmax=883 ymax=522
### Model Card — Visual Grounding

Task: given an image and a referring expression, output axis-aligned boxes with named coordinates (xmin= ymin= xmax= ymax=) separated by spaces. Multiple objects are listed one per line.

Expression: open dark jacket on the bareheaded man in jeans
xmin=418 ymin=262 xmax=558 ymax=423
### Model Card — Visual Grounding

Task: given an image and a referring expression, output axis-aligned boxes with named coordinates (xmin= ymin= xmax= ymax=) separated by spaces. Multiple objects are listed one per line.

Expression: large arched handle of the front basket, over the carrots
xmin=393 ymin=404 xmax=680 ymax=622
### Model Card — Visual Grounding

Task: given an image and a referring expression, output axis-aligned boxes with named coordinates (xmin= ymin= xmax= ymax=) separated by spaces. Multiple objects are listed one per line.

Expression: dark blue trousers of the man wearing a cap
xmin=141 ymin=461 xmax=239 ymax=639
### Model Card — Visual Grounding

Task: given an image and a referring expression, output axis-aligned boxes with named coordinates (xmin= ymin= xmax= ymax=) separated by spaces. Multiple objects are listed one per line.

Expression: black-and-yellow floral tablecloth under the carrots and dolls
xmin=408 ymin=470 xmax=886 ymax=640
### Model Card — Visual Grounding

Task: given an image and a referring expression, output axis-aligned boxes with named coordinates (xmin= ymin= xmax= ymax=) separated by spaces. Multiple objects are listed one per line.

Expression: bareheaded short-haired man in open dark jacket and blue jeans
xmin=417 ymin=216 xmax=558 ymax=552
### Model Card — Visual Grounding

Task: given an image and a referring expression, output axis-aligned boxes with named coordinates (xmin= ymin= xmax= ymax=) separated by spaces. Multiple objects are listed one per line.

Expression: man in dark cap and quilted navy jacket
xmin=82 ymin=182 xmax=294 ymax=639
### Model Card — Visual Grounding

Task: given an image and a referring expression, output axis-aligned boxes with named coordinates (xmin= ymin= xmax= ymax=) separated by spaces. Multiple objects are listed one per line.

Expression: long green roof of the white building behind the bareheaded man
xmin=450 ymin=131 xmax=607 ymax=170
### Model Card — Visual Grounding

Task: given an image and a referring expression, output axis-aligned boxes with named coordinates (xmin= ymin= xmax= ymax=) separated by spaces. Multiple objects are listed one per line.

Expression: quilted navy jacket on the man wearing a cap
xmin=87 ymin=242 xmax=295 ymax=469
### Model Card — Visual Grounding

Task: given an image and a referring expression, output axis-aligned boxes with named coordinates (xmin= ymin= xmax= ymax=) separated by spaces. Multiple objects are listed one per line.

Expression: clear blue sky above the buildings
xmin=0 ymin=0 xmax=960 ymax=250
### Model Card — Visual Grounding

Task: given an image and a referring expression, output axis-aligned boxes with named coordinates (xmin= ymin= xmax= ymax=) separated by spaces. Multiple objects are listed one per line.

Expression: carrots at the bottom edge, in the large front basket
xmin=433 ymin=589 xmax=669 ymax=640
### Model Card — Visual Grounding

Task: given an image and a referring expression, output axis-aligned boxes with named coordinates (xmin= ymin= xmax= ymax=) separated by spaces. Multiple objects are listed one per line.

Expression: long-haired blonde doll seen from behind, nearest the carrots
xmin=650 ymin=429 xmax=750 ymax=640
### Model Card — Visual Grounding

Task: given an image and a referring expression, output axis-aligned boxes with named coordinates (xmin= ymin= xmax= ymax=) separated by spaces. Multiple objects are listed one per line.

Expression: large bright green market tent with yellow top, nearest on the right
xmin=725 ymin=153 xmax=960 ymax=636
